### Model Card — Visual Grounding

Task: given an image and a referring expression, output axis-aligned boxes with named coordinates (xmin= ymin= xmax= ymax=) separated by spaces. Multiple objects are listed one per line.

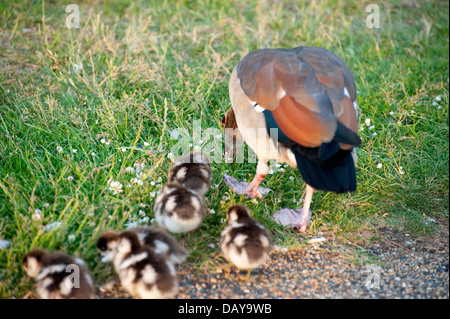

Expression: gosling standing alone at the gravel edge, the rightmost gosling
xmin=220 ymin=205 xmax=272 ymax=280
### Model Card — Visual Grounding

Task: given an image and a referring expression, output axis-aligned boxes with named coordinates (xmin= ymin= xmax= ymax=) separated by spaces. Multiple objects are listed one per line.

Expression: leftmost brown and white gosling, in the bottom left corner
xmin=22 ymin=248 xmax=95 ymax=299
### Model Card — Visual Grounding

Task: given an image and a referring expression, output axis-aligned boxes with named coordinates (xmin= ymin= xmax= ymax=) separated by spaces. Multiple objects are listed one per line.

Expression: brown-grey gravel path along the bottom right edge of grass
xmin=100 ymin=225 xmax=449 ymax=299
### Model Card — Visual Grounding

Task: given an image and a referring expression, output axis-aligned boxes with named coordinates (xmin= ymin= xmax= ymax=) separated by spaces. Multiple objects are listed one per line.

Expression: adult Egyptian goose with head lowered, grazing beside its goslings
xmin=223 ymin=47 xmax=361 ymax=232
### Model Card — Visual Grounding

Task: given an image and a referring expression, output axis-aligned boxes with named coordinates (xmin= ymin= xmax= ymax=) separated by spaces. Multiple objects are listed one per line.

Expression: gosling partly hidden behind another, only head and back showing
xmin=97 ymin=226 xmax=188 ymax=264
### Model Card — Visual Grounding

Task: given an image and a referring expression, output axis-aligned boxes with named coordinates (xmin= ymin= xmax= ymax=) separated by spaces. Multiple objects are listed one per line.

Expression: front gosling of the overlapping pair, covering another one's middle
xmin=109 ymin=231 xmax=178 ymax=299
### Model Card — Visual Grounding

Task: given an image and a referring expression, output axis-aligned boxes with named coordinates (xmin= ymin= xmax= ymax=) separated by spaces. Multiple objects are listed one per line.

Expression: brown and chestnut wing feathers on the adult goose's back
xmin=238 ymin=47 xmax=358 ymax=149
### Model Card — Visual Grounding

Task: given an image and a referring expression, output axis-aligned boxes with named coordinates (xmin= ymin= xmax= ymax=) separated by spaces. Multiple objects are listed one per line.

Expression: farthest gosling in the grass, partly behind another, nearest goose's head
xmin=169 ymin=152 xmax=211 ymax=196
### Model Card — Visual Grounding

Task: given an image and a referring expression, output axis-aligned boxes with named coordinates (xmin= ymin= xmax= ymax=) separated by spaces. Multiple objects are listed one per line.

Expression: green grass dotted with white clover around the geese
xmin=0 ymin=0 xmax=449 ymax=298
